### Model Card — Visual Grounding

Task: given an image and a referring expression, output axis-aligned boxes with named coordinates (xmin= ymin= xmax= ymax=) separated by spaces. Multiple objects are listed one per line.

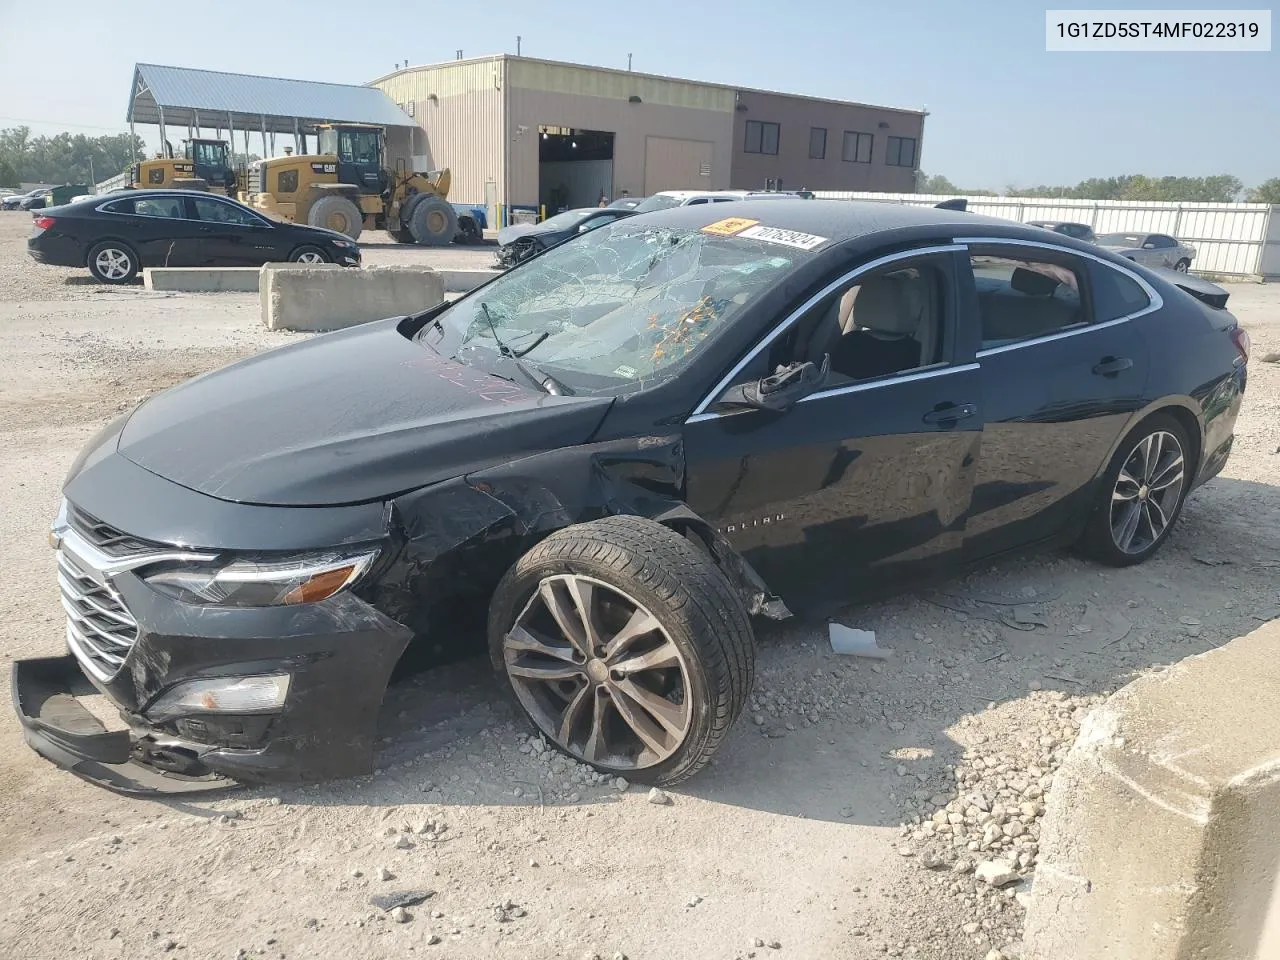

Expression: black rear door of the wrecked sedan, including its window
xmin=965 ymin=241 xmax=1152 ymax=559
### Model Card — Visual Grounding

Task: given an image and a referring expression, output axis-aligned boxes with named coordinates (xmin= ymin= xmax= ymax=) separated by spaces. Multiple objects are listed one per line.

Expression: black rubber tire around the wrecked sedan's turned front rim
xmin=488 ymin=517 xmax=755 ymax=783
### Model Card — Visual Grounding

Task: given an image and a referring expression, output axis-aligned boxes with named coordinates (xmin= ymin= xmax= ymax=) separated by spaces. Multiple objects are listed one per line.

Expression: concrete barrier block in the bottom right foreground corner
xmin=1023 ymin=621 xmax=1280 ymax=960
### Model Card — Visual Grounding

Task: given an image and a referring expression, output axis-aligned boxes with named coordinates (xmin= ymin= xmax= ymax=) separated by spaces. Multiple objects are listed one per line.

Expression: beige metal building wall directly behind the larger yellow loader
xmin=372 ymin=58 xmax=504 ymax=209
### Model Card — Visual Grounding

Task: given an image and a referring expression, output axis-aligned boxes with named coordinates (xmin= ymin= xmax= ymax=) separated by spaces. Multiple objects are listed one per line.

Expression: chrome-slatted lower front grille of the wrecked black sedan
xmin=58 ymin=547 xmax=138 ymax=681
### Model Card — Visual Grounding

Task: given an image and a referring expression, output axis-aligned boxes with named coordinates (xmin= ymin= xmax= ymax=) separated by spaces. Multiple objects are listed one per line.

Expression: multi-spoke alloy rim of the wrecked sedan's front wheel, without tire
xmin=503 ymin=573 xmax=692 ymax=769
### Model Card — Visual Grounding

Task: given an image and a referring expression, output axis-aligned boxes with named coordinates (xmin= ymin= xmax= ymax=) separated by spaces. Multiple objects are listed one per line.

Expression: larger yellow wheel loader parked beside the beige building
xmin=247 ymin=123 xmax=468 ymax=247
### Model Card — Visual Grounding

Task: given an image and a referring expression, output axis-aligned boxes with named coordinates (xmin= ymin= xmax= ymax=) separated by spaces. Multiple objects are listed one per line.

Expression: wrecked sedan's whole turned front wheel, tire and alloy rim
xmin=489 ymin=517 xmax=755 ymax=783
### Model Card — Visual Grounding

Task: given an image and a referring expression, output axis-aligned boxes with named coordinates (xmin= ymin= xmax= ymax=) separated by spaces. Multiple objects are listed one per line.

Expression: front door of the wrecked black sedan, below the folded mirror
xmin=685 ymin=248 xmax=983 ymax=609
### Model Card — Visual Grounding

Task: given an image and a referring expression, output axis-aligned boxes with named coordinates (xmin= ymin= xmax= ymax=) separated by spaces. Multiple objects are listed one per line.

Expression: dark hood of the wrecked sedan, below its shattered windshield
xmin=118 ymin=319 xmax=612 ymax=506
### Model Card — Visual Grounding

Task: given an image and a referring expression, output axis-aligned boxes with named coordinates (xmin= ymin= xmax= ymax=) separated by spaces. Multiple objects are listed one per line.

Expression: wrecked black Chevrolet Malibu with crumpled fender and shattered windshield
xmin=14 ymin=200 xmax=1248 ymax=792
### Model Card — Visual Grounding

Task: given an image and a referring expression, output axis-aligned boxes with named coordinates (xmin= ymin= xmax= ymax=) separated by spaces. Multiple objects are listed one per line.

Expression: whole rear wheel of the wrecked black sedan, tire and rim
xmin=1080 ymin=413 xmax=1192 ymax=567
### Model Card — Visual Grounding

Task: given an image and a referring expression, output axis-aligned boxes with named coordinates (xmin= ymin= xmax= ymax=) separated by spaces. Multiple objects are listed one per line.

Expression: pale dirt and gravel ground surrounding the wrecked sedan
xmin=0 ymin=214 xmax=1280 ymax=960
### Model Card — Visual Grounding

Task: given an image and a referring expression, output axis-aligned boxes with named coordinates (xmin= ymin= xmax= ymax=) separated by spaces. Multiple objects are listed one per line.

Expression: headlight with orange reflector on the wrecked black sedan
xmin=141 ymin=549 xmax=378 ymax=607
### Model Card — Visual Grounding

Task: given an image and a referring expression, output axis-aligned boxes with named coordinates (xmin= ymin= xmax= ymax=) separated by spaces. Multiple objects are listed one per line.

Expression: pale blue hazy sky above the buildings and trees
xmin=0 ymin=0 xmax=1280 ymax=189
